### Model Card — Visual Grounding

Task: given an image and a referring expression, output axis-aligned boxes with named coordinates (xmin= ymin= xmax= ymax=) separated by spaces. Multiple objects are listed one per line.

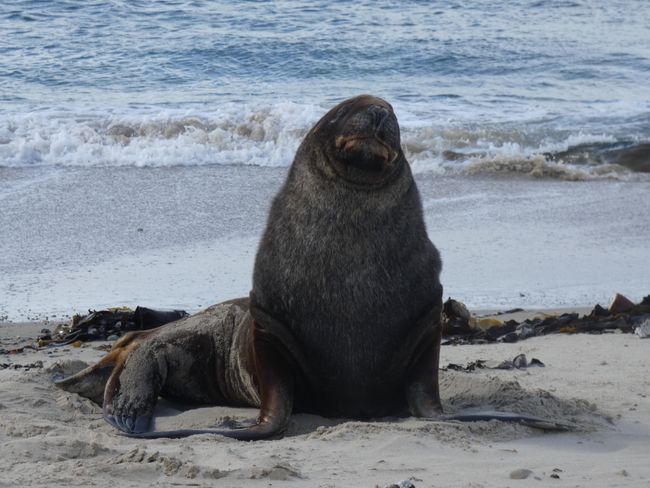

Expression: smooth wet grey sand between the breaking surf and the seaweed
xmin=0 ymin=166 xmax=650 ymax=321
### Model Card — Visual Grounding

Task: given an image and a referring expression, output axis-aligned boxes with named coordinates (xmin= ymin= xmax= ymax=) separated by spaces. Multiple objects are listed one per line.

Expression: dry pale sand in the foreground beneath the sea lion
xmin=0 ymin=314 xmax=650 ymax=488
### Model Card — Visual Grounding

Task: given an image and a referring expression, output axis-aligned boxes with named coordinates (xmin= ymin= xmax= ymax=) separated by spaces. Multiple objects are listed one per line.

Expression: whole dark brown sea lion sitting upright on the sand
xmin=58 ymin=95 xmax=572 ymax=440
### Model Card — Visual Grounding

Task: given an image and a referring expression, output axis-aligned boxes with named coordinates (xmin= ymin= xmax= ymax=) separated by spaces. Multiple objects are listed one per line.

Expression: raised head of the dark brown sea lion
xmin=306 ymin=95 xmax=406 ymax=188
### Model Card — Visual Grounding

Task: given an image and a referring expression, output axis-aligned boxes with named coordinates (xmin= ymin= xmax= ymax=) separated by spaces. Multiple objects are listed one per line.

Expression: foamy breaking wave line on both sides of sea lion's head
xmin=0 ymin=102 xmax=650 ymax=180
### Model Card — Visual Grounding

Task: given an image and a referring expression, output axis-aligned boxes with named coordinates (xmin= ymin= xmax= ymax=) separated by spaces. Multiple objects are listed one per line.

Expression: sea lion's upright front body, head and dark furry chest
xmin=246 ymin=95 xmax=442 ymax=424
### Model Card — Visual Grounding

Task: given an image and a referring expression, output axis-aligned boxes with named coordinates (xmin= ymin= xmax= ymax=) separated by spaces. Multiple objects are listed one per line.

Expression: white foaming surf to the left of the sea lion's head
xmin=0 ymin=103 xmax=322 ymax=167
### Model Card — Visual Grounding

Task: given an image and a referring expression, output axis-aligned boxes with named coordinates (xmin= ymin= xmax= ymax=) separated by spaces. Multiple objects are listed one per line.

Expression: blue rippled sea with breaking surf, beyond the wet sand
xmin=0 ymin=0 xmax=650 ymax=179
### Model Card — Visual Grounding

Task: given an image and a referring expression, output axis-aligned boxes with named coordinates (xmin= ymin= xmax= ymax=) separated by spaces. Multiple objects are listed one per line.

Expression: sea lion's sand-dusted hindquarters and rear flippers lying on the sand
xmin=55 ymin=298 xmax=259 ymax=432
